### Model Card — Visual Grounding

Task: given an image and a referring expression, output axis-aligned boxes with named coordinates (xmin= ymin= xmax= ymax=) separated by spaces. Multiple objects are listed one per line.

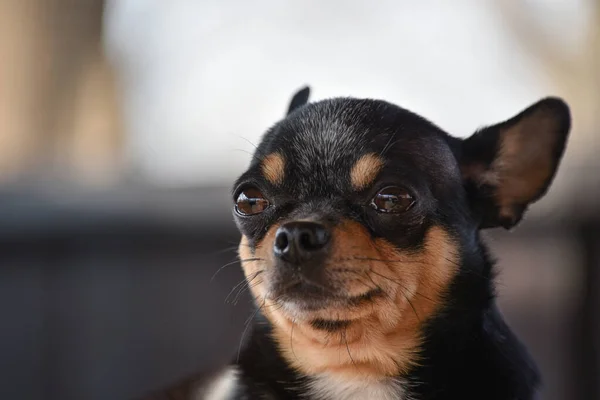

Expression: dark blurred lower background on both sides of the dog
xmin=0 ymin=188 xmax=600 ymax=400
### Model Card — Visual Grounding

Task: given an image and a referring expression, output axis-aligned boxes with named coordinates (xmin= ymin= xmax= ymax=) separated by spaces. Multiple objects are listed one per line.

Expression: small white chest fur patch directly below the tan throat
xmin=307 ymin=376 xmax=414 ymax=400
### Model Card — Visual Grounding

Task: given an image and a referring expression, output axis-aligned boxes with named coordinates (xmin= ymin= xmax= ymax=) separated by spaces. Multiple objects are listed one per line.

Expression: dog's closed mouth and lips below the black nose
xmin=269 ymin=281 xmax=383 ymax=315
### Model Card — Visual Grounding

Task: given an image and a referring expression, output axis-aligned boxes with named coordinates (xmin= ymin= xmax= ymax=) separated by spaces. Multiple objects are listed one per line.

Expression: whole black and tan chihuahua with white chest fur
xmin=204 ymin=88 xmax=571 ymax=400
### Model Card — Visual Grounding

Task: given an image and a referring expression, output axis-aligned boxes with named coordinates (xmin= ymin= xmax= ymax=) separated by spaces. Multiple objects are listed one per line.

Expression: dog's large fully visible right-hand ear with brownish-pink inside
xmin=458 ymin=98 xmax=571 ymax=229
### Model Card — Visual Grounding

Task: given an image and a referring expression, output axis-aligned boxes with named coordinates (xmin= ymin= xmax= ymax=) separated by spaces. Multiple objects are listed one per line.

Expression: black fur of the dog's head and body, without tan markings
xmin=221 ymin=88 xmax=570 ymax=400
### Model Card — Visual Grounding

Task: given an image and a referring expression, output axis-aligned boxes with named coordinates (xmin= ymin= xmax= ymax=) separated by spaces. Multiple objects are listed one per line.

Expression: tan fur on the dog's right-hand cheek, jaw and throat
xmin=264 ymin=222 xmax=458 ymax=380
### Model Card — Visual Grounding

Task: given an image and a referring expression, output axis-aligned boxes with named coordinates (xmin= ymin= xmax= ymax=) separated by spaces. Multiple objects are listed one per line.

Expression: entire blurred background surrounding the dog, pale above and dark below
xmin=0 ymin=0 xmax=600 ymax=400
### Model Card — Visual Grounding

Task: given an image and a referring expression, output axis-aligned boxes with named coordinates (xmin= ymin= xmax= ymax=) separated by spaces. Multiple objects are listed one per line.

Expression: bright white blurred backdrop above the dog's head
xmin=106 ymin=0 xmax=585 ymax=185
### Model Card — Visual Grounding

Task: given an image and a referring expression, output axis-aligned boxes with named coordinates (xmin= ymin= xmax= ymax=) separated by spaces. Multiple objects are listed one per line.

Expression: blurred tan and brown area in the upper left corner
xmin=0 ymin=0 xmax=122 ymax=184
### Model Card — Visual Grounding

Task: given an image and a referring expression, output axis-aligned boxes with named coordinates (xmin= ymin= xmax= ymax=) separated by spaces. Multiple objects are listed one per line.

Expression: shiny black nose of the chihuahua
xmin=274 ymin=221 xmax=329 ymax=264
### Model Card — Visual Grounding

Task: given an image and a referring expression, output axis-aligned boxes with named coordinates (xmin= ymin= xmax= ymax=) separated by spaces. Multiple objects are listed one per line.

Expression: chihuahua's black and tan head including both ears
xmin=233 ymin=86 xmax=570 ymax=376
